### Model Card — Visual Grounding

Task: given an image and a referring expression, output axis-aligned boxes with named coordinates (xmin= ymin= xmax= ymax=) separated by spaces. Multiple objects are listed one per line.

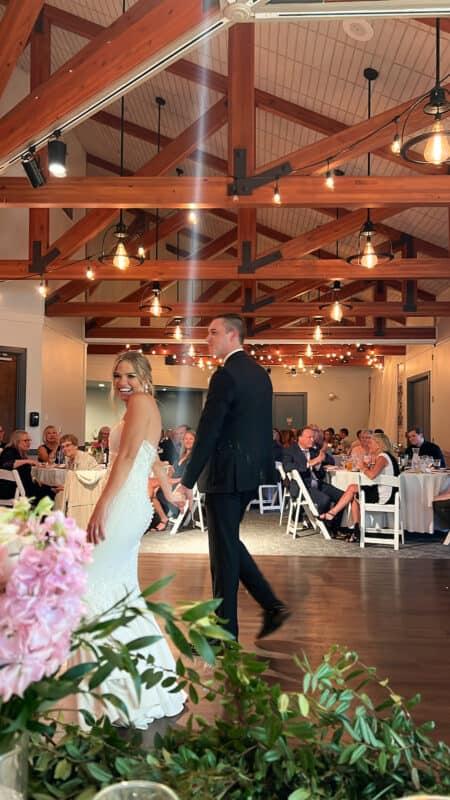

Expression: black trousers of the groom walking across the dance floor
xmin=206 ymin=489 xmax=278 ymax=639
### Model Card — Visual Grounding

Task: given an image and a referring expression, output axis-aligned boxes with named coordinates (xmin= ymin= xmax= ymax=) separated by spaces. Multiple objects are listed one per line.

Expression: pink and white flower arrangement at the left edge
xmin=0 ymin=498 xmax=92 ymax=746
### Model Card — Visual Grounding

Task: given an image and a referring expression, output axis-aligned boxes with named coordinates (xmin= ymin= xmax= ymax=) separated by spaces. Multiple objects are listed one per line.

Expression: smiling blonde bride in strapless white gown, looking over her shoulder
xmin=83 ymin=350 xmax=186 ymax=728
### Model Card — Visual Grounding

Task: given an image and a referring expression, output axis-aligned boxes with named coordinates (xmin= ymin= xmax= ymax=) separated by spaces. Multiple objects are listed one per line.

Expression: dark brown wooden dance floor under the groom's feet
xmin=140 ymin=553 xmax=450 ymax=743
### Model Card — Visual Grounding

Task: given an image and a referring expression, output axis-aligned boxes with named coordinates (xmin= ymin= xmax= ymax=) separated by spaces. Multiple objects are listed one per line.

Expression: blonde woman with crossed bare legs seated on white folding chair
xmin=321 ymin=433 xmax=400 ymax=542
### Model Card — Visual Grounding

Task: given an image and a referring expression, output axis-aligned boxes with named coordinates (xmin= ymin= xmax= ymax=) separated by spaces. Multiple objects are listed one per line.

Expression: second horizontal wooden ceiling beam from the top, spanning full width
xmin=5 ymin=258 xmax=450 ymax=281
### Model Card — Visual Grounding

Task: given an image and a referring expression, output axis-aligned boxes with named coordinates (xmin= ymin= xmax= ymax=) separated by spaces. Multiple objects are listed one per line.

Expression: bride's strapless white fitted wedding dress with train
xmin=82 ymin=421 xmax=186 ymax=728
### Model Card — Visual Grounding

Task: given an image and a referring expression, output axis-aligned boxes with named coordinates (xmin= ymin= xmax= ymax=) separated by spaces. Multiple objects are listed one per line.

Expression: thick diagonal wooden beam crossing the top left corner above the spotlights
xmin=0 ymin=0 xmax=217 ymax=161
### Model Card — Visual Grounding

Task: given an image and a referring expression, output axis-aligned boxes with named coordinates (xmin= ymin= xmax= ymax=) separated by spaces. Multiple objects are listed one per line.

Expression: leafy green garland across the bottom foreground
xmin=24 ymin=580 xmax=450 ymax=800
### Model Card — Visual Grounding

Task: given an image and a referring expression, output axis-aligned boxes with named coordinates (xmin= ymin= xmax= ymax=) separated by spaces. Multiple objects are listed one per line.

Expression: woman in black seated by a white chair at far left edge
xmin=0 ymin=430 xmax=55 ymax=503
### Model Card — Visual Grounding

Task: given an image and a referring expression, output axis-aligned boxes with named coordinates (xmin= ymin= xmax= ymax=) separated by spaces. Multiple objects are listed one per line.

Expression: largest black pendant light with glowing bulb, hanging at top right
xmin=400 ymin=19 xmax=450 ymax=166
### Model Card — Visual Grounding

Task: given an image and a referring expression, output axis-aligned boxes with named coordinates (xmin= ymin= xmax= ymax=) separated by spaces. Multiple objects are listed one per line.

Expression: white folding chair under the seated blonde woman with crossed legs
xmin=359 ymin=475 xmax=404 ymax=550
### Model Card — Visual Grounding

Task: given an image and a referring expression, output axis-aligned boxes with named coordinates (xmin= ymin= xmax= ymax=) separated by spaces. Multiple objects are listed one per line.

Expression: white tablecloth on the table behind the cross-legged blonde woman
xmin=328 ymin=470 xmax=450 ymax=533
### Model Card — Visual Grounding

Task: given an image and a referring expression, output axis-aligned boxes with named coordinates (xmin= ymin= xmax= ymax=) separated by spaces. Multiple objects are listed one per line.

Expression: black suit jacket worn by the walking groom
xmin=183 ymin=350 xmax=274 ymax=494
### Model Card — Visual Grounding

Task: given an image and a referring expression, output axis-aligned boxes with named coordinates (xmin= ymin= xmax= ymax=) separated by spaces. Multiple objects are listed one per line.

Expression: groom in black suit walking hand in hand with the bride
xmin=179 ymin=314 xmax=290 ymax=639
